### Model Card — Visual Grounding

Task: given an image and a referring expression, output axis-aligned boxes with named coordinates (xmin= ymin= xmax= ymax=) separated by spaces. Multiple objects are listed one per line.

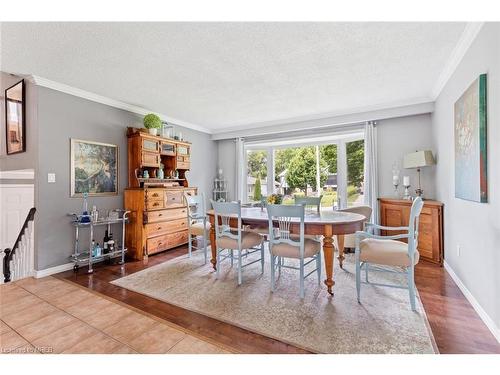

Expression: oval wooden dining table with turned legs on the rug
xmin=207 ymin=207 xmax=366 ymax=296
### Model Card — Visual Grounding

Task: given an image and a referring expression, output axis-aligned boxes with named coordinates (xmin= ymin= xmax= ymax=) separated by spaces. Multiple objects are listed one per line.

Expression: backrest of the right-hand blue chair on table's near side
xmin=267 ymin=204 xmax=305 ymax=258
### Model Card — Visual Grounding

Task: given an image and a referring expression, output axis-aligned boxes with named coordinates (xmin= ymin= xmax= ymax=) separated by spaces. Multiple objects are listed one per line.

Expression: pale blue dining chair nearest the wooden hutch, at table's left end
xmin=184 ymin=193 xmax=211 ymax=264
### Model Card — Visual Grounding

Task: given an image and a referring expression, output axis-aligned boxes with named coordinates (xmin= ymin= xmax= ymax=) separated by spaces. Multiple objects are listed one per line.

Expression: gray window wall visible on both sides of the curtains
xmin=217 ymin=114 xmax=435 ymax=204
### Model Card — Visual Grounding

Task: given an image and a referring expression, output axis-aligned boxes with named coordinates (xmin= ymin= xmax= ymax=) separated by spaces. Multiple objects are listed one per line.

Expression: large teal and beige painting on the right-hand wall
xmin=455 ymin=74 xmax=488 ymax=203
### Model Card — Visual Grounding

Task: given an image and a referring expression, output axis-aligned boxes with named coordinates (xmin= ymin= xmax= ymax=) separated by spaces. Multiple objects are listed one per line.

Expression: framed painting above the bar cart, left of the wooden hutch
xmin=71 ymin=139 xmax=118 ymax=197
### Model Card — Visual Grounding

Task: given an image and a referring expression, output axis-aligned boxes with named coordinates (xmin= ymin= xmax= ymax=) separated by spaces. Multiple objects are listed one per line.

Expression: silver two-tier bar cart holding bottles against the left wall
xmin=68 ymin=209 xmax=130 ymax=273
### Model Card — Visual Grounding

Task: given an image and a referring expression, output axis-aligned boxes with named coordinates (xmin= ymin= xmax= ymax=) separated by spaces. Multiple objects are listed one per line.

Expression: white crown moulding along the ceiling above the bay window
xmin=211 ymin=98 xmax=434 ymax=141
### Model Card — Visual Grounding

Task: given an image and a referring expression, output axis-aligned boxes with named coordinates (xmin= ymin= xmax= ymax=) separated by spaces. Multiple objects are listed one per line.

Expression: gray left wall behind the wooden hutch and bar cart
xmin=35 ymin=87 xmax=217 ymax=270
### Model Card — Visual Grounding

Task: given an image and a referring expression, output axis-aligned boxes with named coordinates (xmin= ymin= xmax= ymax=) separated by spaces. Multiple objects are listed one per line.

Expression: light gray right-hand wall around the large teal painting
xmin=432 ymin=23 xmax=500 ymax=330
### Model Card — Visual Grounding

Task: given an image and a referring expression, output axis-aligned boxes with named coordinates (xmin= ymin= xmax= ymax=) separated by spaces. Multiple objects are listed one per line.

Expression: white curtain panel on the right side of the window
xmin=364 ymin=121 xmax=379 ymax=224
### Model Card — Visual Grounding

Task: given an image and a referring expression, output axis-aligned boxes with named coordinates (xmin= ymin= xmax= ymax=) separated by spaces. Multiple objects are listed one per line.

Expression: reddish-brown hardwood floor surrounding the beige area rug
xmin=55 ymin=246 xmax=500 ymax=353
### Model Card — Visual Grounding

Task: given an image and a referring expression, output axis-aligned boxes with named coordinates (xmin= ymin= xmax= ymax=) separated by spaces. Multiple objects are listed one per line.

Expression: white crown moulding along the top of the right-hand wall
xmin=431 ymin=22 xmax=484 ymax=100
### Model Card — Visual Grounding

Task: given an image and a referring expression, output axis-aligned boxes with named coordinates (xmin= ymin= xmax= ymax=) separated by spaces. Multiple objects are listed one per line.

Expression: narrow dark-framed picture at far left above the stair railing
xmin=5 ymin=79 xmax=26 ymax=155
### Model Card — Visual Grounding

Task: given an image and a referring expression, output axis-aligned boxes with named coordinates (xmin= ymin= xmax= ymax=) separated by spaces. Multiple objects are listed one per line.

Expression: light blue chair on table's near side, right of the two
xmin=267 ymin=204 xmax=321 ymax=298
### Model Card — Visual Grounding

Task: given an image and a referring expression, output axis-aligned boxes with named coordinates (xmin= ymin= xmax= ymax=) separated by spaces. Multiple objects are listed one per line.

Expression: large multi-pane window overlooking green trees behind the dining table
xmin=245 ymin=133 xmax=364 ymax=210
